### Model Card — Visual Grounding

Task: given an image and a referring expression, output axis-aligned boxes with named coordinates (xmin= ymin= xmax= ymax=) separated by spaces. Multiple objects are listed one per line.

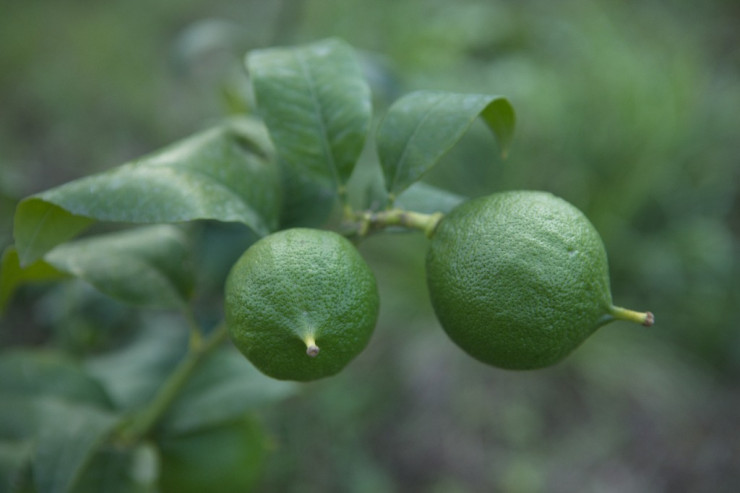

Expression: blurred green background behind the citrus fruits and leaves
xmin=0 ymin=0 xmax=740 ymax=493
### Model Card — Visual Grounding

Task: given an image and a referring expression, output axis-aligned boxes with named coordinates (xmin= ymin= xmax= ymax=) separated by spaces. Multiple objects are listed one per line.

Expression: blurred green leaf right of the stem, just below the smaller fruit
xmin=161 ymin=346 xmax=298 ymax=435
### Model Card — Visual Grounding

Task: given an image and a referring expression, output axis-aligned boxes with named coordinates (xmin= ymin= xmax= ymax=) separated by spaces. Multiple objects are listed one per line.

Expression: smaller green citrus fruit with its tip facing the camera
xmin=225 ymin=228 xmax=379 ymax=381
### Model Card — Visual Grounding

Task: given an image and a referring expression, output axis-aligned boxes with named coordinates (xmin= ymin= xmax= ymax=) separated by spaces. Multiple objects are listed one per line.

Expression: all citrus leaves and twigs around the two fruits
xmin=0 ymin=39 xmax=514 ymax=492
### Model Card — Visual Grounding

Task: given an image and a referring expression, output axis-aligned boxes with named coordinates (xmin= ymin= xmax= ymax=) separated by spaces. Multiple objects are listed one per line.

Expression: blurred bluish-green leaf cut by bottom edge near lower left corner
xmin=33 ymin=400 xmax=118 ymax=493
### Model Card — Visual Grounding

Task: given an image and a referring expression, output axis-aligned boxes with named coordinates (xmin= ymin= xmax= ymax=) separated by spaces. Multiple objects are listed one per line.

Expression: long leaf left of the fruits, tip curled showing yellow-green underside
xmin=14 ymin=119 xmax=280 ymax=265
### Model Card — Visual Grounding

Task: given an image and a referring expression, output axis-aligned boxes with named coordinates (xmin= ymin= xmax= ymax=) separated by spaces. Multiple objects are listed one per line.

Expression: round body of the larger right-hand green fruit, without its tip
xmin=426 ymin=191 xmax=614 ymax=369
